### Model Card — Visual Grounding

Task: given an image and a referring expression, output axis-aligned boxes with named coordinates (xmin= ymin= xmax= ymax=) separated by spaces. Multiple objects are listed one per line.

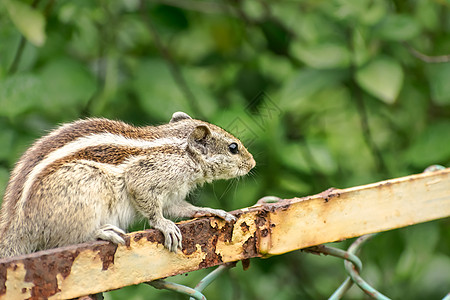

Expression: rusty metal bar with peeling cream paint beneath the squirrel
xmin=0 ymin=169 xmax=450 ymax=299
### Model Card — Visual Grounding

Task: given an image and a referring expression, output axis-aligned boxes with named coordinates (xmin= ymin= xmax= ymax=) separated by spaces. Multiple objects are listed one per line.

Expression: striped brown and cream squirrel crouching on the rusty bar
xmin=0 ymin=112 xmax=255 ymax=257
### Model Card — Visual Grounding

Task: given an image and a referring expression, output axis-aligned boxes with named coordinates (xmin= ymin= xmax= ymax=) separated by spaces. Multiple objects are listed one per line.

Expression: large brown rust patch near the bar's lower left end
xmin=22 ymin=250 xmax=80 ymax=299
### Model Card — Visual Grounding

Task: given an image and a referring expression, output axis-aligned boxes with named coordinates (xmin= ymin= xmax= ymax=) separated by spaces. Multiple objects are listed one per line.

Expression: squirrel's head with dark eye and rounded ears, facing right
xmin=170 ymin=112 xmax=256 ymax=181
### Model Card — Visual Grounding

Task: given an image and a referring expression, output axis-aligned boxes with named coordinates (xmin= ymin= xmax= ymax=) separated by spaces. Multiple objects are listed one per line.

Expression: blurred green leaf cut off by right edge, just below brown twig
xmin=427 ymin=63 xmax=450 ymax=105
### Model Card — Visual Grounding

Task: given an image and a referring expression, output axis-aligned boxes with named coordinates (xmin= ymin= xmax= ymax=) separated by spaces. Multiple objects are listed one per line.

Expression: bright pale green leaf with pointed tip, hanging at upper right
xmin=356 ymin=57 xmax=403 ymax=104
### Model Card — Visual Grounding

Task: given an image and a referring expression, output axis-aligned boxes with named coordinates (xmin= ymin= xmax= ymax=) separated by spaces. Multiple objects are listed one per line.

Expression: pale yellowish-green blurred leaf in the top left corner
xmin=4 ymin=0 xmax=46 ymax=47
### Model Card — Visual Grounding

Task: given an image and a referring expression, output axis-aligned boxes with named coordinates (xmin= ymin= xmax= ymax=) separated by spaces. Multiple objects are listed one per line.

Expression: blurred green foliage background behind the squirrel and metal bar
xmin=0 ymin=0 xmax=450 ymax=299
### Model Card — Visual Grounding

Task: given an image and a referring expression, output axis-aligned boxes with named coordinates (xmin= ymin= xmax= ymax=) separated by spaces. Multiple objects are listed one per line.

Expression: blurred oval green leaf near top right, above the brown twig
xmin=376 ymin=15 xmax=421 ymax=41
